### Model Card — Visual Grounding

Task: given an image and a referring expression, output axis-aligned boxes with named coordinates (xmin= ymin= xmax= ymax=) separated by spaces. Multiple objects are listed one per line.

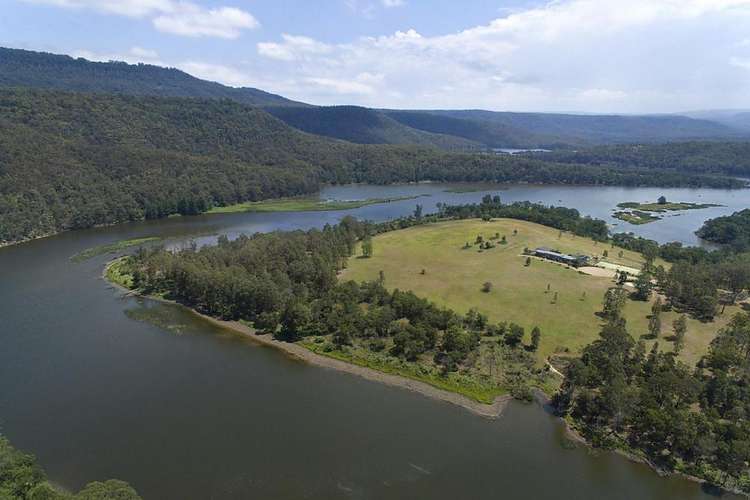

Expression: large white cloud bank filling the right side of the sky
xmin=257 ymin=0 xmax=750 ymax=112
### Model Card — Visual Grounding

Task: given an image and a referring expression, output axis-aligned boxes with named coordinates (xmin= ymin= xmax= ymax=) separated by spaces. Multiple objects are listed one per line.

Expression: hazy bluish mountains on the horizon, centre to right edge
xmin=267 ymin=106 xmax=743 ymax=149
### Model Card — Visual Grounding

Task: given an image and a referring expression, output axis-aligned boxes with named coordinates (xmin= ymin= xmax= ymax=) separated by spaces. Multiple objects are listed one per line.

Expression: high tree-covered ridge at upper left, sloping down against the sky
xmin=0 ymin=47 xmax=306 ymax=106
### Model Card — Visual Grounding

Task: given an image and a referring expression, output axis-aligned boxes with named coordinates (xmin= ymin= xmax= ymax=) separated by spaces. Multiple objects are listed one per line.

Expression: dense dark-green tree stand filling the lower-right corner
xmin=555 ymin=308 xmax=750 ymax=492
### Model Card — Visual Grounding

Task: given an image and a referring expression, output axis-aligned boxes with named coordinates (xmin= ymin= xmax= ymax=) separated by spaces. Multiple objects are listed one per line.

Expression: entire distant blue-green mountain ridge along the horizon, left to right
xmin=0 ymin=48 xmax=750 ymax=150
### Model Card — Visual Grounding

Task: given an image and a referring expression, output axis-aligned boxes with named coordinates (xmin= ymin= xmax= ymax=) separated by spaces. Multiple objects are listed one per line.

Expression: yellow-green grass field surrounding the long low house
xmin=341 ymin=219 xmax=737 ymax=362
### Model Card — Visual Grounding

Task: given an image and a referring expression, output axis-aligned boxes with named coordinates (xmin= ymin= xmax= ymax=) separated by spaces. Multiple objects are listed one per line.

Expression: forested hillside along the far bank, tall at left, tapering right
xmin=0 ymin=89 xmax=744 ymax=243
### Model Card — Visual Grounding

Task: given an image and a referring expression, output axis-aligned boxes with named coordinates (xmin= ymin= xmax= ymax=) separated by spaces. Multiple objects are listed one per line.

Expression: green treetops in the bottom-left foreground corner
xmin=0 ymin=436 xmax=140 ymax=500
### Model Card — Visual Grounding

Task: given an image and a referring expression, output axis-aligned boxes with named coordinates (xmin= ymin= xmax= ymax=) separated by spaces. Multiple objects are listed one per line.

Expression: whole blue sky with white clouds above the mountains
xmin=0 ymin=0 xmax=750 ymax=113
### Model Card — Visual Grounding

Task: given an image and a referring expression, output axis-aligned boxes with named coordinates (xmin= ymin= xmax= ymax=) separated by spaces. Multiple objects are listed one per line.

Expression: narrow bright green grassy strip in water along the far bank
xmin=206 ymin=196 xmax=416 ymax=214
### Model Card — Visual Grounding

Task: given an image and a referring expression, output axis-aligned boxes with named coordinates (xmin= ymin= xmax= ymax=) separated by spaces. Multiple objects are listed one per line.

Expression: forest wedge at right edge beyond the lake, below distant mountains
xmin=536 ymin=141 xmax=750 ymax=177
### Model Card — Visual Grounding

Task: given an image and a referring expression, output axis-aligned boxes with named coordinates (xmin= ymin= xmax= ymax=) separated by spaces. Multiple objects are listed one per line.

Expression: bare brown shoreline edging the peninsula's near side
xmin=102 ymin=257 xmax=513 ymax=419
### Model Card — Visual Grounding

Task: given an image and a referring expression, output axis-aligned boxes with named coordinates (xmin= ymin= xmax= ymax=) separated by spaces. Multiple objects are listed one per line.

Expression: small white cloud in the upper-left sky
xmin=22 ymin=0 xmax=259 ymax=39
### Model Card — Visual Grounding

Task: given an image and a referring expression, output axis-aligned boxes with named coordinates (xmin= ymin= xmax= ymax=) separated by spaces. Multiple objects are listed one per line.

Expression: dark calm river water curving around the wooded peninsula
xmin=0 ymin=184 xmax=748 ymax=499
